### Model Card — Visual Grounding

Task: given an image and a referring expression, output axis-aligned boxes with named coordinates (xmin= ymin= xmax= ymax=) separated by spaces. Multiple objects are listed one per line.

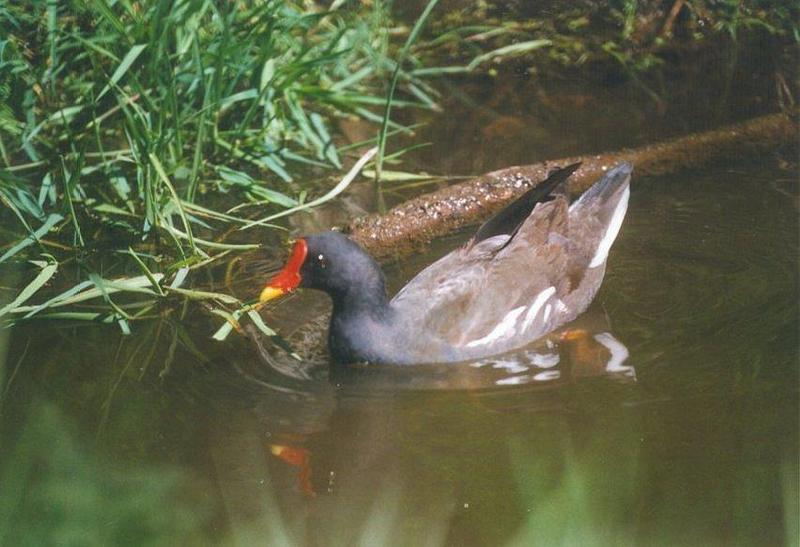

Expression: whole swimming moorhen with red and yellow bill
xmin=260 ymin=163 xmax=633 ymax=365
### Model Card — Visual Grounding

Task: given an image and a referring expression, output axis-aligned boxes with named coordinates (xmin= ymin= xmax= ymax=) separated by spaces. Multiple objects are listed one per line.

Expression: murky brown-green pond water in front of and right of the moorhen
xmin=0 ymin=79 xmax=799 ymax=546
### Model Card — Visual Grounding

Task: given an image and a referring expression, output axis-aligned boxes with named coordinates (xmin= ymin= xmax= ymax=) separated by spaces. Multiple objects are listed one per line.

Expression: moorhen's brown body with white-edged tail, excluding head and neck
xmin=391 ymin=164 xmax=632 ymax=362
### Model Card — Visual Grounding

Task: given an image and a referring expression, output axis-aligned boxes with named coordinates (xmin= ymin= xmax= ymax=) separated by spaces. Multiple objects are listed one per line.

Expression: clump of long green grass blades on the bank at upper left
xmin=0 ymin=0 xmax=437 ymax=337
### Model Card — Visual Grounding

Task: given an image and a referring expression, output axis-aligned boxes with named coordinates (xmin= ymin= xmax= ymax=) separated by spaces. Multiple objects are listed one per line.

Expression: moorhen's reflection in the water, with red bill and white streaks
xmin=226 ymin=306 xmax=636 ymax=510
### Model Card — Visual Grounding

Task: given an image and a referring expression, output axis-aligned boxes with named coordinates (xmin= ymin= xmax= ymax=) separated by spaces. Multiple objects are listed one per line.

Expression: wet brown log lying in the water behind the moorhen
xmin=348 ymin=114 xmax=798 ymax=258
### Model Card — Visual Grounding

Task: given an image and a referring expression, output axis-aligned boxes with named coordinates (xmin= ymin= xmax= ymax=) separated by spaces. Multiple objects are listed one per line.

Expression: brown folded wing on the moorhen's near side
xmin=392 ymin=196 xmax=568 ymax=348
